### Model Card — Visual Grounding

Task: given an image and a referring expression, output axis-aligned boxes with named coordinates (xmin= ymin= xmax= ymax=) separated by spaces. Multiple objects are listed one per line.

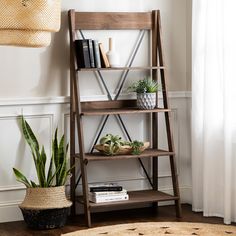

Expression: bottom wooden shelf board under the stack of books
xmin=76 ymin=190 xmax=179 ymax=208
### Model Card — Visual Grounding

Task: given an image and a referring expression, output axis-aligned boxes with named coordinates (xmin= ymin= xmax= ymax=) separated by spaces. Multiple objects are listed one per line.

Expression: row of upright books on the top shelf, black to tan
xmin=75 ymin=39 xmax=110 ymax=68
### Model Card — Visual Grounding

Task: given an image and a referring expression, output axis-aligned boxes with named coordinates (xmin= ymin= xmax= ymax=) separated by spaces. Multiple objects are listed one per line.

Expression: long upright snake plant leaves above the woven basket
xmin=13 ymin=116 xmax=71 ymax=188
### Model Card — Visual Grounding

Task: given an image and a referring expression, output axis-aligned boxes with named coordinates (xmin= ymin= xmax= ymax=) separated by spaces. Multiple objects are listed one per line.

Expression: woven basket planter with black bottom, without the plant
xmin=19 ymin=186 xmax=72 ymax=229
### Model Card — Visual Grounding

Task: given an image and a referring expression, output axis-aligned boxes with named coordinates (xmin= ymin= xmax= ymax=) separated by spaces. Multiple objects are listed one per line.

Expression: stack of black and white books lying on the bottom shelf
xmin=89 ymin=183 xmax=129 ymax=203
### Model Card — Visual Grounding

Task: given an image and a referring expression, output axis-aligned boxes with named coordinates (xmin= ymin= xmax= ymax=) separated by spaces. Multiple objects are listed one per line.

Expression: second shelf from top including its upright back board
xmin=80 ymin=99 xmax=171 ymax=116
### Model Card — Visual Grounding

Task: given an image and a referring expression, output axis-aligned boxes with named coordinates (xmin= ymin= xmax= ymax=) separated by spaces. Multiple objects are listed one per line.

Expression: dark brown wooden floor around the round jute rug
xmin=0 ymin=204 xmax=230 ymax=236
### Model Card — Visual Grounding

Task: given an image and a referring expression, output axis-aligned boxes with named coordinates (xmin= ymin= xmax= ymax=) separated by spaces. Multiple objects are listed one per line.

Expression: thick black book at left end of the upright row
xmin=75 ymin=39 xmax=91 ymax=68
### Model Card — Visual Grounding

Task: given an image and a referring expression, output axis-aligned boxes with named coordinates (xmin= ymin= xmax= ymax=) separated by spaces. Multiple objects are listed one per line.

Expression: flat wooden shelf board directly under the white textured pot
xmin=80 ymin=107 xmax=171 ymax=116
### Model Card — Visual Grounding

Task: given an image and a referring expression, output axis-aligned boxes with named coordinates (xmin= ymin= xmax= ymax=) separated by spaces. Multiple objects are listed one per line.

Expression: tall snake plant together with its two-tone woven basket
xmin=13 ymin=116 xmax=72 ymax=229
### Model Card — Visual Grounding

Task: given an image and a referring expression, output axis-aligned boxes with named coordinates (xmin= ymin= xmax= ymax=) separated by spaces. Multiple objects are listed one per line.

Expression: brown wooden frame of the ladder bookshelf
xmin=69 ymin=10 xmax=181 ymax=227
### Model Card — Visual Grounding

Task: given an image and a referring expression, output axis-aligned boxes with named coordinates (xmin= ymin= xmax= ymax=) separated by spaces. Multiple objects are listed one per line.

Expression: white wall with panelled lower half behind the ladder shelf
xmin=0 ymin=0 xmax=191 ymax=222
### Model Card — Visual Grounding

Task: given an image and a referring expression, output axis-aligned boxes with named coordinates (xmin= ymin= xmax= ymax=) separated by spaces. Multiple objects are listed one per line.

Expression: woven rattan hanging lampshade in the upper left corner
xmin=0 ymin=0 xmax=61 ymax=47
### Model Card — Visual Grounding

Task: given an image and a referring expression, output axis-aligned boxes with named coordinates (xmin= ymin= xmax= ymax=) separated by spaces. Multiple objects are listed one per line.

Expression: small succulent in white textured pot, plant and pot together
xmin=128 ymin=78 xmax=158 ymax=109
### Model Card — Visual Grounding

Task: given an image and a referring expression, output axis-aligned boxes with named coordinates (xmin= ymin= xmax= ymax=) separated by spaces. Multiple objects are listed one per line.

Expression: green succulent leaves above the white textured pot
xmin=128 ymin=78 xmax=159 ymax=93
